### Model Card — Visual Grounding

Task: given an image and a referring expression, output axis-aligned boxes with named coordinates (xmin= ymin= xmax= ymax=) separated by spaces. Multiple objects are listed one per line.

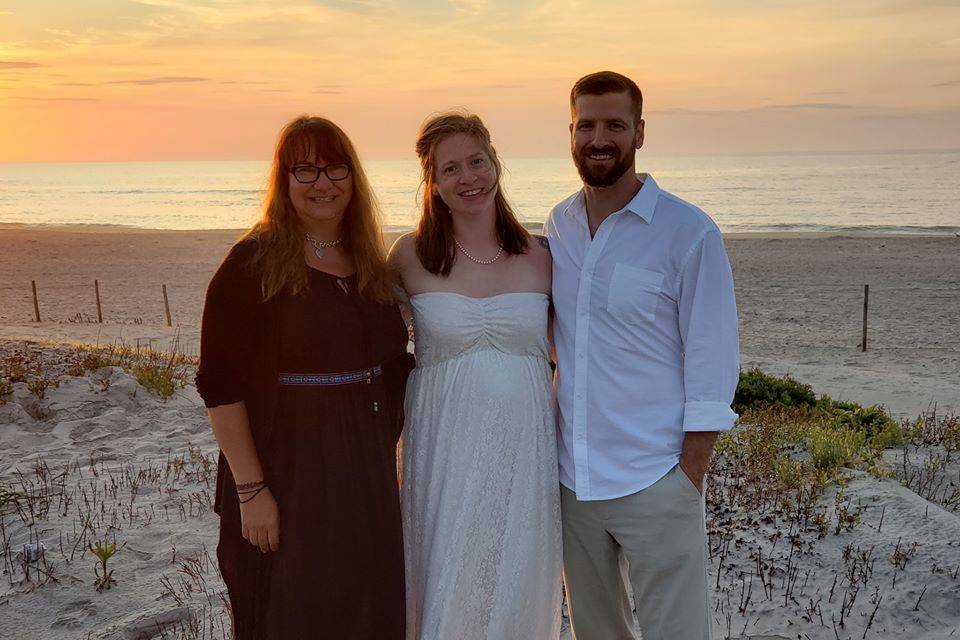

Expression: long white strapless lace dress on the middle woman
xmin=402 ymin=292 xmax=563 ymax=640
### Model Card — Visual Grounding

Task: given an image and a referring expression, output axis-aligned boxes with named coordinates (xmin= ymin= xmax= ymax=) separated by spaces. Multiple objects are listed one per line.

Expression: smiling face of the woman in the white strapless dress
xmin=431 ymin=133 xmax=497 ymax=218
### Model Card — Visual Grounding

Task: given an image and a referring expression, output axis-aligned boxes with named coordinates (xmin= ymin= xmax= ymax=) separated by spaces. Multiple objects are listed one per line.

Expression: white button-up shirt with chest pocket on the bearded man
xmin=544 ymin=175 xmax=739 ymax=500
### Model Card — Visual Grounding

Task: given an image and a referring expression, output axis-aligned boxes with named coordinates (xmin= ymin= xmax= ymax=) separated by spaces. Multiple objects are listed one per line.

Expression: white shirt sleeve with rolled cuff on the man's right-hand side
xmin=678 ymin=229 xmax=740 ymax=432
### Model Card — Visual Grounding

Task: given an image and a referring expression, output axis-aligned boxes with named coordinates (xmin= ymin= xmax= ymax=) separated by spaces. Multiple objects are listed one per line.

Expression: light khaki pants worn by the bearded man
xmin=560 ymin=465 xmax=710 ymax=640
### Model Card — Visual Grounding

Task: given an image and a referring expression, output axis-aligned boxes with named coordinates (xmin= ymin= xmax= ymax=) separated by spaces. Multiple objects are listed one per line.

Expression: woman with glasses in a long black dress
xmin=197 ymin=117 xmax=413 ymax=640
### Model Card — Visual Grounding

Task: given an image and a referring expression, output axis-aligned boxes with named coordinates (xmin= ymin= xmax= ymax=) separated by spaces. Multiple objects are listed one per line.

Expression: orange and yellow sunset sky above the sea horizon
xmin=0 ymin=0 xmax=960 ymax=162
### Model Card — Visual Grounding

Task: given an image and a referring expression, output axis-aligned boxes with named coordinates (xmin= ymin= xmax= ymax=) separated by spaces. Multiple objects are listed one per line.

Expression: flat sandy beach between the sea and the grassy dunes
xmin=0 ymin=226 xmax=960 ymax=416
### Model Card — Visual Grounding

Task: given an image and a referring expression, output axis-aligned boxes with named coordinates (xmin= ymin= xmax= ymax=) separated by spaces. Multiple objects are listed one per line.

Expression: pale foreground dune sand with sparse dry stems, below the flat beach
xmin=0 ymin=342 xmax=960 ymax=640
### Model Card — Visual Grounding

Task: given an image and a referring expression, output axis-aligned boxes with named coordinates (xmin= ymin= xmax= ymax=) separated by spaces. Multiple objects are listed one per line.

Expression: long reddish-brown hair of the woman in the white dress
xmin=415 ymin=112 xmax=530 ymax=276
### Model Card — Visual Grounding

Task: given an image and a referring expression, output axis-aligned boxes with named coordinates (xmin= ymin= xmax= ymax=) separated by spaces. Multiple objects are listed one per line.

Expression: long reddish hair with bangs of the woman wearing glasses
xmin=244 ymin=115 xmax=395 ymax=302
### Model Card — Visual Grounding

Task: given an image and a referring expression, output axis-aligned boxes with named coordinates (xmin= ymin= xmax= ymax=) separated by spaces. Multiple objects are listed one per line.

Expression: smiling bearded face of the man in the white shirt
xmin=570 ymin=92 xmax=643 ymax=187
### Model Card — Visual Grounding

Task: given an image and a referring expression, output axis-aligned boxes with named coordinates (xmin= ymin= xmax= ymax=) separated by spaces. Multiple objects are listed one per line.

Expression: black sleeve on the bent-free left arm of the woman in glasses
xmin=196 ymin=244 xmax=259 ymax=408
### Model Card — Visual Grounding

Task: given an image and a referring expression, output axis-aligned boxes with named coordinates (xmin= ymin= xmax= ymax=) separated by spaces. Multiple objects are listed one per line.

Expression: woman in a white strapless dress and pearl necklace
xmin=390 ymin=113 xmax=562 ymax=640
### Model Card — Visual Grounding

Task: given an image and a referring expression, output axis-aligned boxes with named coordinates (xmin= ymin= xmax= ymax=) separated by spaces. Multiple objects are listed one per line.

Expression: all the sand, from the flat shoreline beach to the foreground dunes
xmin=0 ymin=226 xmax=960 ymax=640
